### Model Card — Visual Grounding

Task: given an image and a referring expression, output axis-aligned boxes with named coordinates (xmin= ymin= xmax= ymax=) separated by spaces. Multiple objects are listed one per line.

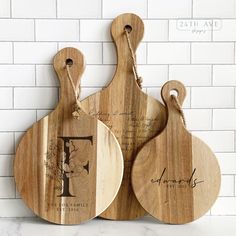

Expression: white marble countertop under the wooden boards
xmin=0 ymin=216 xmax=236 ymax=236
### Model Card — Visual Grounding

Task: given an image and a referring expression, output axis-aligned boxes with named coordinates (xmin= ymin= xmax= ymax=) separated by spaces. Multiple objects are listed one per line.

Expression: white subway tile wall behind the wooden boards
xmin=0 ymin=0 xmax=236 ymax=217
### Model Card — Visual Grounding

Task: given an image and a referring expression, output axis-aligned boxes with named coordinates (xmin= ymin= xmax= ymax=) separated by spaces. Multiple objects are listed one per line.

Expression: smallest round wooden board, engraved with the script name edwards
xmin=132 ymin=81 xmax=221 ymax=224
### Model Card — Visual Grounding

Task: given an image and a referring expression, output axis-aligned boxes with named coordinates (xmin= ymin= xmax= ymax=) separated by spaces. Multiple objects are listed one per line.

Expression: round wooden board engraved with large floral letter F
xmin=14 ymin=48 xmax=123 ymax=224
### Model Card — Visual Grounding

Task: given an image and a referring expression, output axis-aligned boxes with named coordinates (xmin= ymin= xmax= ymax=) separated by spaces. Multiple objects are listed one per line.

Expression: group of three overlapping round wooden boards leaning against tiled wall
xmin=14 ymin=13 xmax=220 ymax=224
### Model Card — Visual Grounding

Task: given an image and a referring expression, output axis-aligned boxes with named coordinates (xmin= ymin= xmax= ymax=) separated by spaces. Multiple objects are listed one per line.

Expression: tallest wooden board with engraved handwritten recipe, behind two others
xmin=82 ymin=14 xmax=166 ymax=220
